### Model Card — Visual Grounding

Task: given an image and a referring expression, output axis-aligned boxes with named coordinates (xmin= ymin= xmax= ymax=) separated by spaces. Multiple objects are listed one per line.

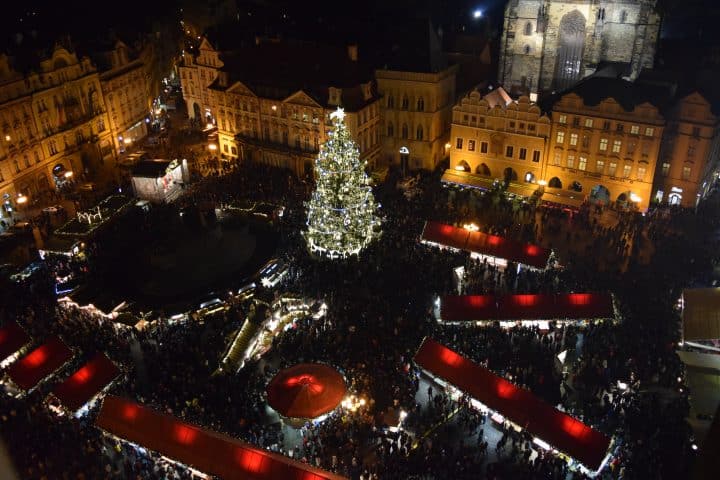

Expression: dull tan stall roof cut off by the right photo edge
xmin=682 ymin=288 xmax=720 ymax=341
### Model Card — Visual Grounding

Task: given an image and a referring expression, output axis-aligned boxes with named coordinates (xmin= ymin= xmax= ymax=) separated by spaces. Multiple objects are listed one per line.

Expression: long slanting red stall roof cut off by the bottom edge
xmin=95 ymin=395 xmax=345 ymax=480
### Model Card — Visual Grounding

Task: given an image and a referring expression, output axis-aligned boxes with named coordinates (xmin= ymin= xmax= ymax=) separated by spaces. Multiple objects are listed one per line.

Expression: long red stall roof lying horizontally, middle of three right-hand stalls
xmin=440 ymin=293 xmax=615 ymax=322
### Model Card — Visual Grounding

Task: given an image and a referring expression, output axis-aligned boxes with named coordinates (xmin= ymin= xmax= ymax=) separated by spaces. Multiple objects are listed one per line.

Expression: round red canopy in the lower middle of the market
xmin=267 ymin=363 xmax=347 ymax=418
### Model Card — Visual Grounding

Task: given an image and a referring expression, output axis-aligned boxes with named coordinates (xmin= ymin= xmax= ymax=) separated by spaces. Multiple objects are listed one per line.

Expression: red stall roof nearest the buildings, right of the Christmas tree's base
xmin=422 ymin=221 xmax=550 ymax=269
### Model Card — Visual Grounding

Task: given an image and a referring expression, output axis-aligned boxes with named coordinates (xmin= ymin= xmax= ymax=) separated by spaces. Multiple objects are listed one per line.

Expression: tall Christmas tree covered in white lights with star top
xmin=305 ymin=108 xmax=379 ymax=258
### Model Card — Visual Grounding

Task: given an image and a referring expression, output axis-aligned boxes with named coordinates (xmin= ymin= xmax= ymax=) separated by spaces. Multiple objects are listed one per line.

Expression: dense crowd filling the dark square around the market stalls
xmin=0 ymin=147 xmax=717 ymax=480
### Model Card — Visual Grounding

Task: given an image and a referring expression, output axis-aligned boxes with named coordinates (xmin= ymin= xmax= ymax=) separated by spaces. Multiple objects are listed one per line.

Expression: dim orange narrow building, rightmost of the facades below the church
xmin=653 ymin=92 xmax=719 ymax=207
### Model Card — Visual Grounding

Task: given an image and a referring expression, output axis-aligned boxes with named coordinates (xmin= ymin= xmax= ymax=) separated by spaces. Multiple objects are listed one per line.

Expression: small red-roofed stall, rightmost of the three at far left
xmin=52 ymin=353 xmax=120 ymax=411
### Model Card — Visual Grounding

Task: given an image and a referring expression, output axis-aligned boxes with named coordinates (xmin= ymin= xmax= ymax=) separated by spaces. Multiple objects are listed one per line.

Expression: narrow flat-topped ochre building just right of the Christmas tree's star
xmin=375 ymin=65 xmax=458 ymax=172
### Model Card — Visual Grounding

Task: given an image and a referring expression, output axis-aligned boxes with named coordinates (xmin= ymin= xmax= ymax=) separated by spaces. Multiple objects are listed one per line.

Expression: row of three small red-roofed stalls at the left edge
xmin=0 ymin=321 xmax=121 ymax=415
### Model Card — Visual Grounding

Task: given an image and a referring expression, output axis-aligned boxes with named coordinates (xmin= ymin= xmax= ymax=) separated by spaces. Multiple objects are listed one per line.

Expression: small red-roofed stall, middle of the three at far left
xmin=8 ymin=336 xmax=73 ymax=390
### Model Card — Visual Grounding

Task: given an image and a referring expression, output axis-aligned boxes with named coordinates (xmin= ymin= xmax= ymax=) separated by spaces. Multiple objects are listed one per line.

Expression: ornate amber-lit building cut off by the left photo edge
xmin=0 ymin=46 xmax=113 ymax=217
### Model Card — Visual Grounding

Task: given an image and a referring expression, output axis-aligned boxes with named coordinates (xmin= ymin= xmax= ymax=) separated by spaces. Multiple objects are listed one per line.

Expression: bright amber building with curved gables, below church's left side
xmin=443 ymin=88 xmax=551 ymax=196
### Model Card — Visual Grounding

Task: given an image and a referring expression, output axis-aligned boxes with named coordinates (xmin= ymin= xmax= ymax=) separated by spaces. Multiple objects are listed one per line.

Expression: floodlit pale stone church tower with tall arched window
xmin=498 ymin=0 xmax=660 ymax=95
